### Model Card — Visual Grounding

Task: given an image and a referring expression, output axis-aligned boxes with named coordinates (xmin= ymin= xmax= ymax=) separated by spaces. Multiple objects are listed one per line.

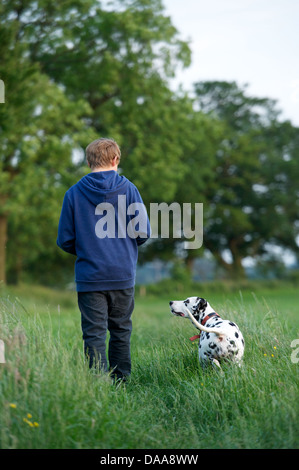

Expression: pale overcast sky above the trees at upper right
xmin=162 ymin=0 xmax=299 ymax=126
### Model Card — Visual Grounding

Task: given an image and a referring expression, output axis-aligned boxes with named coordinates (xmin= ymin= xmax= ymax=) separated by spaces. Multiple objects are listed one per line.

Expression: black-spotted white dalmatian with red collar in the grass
xmin=169 ymin=297 xmax=245 ymax=368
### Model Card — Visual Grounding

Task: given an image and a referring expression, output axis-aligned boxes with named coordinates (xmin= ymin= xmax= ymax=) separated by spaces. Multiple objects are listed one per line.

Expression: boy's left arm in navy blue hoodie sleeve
xmin=57 ymin=193 xmax=76 ymax=255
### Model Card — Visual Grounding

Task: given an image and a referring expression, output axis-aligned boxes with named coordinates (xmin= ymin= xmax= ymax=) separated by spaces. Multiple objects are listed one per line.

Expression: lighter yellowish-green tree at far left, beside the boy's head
xmin=0 ymin=2 xmax=94 ymax=282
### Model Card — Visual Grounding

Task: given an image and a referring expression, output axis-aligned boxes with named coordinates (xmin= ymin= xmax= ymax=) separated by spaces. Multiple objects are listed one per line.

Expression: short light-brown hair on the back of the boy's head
xmin=86 ymin=137 xmax=121 ymax=168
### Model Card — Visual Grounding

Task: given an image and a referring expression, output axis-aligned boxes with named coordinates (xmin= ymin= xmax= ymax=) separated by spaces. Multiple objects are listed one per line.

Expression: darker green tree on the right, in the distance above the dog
xmin=195 ymin=82 xmax=299 ymax=277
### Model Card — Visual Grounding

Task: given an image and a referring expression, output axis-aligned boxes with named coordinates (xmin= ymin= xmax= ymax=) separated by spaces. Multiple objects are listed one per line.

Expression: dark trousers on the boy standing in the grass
xmin=78 ymin=287 xmax=134 ymax=379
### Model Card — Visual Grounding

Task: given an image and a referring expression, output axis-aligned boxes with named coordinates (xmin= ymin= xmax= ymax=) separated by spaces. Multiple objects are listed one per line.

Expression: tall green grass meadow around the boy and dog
xmin=0 ymin=284 xmax=299 ymax=449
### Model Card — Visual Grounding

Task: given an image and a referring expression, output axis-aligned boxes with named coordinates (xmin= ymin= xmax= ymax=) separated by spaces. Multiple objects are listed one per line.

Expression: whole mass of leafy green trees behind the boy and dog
xmin=0 ymin=0 xmax=299 ymax=282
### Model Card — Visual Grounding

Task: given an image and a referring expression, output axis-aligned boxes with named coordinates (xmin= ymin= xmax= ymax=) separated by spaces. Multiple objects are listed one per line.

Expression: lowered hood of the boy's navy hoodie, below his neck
xmin=77 ymin=170 xmax=129 ymax=206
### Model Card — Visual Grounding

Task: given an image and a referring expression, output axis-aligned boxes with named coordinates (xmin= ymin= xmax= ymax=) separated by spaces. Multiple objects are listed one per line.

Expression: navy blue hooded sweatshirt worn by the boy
xmin=57 ymin=170 xmax=150 ymax=292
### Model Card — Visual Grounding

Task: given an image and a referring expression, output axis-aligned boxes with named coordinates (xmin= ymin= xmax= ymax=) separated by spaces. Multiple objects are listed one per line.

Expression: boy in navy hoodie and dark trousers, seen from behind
xmin=57 ymin=138 xmax=150 ymax=380
